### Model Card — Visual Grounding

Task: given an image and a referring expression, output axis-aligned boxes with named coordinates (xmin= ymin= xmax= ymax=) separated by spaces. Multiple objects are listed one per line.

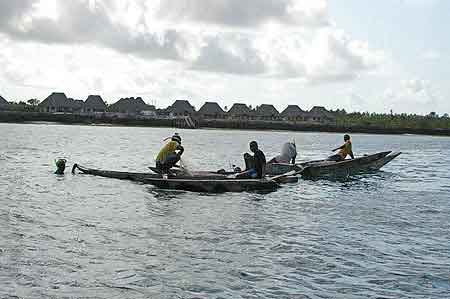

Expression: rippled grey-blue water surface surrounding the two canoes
xmin=0 ymin=124 xmax=450 ymax=298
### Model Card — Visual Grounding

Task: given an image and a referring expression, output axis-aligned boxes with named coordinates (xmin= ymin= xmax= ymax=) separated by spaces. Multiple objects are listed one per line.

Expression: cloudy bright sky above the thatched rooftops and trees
xmin=0 ymin=0 xmax=450 ymax=114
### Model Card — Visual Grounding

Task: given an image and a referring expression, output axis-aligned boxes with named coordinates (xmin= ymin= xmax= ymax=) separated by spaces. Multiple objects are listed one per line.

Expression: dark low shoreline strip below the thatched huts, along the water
xmin=0 ymin=112 xmax=450 ymax=137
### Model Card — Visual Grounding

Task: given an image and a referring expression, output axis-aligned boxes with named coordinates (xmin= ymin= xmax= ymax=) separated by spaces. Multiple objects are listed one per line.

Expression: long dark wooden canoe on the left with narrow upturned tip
xmin=72 ymin=164 xmax=280 ymax=193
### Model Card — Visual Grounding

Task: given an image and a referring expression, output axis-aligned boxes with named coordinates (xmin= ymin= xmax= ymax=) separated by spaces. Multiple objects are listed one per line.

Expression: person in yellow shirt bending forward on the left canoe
xmin=155 ymin=133 xmax=184 ymax=173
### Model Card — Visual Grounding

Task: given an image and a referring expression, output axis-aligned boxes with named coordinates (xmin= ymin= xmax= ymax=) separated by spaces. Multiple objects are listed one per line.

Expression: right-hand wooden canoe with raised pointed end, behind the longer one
xmin=266 ymin=151 xmax=401 ymax=178
